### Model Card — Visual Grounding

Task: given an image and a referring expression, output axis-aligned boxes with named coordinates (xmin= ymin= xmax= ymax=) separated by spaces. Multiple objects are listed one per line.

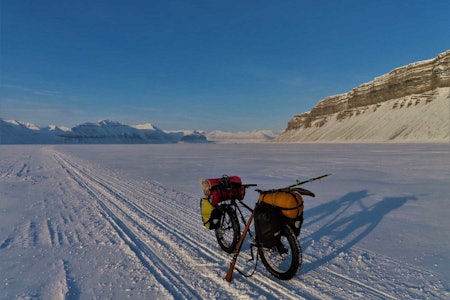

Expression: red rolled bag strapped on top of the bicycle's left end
xmin=200 ymin=175 xmax=245 ymax=206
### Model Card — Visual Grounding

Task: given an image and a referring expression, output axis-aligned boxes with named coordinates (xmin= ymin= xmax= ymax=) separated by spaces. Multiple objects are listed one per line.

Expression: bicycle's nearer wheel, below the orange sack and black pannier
xmin=258 ymin=224 xmax=302 ymax=280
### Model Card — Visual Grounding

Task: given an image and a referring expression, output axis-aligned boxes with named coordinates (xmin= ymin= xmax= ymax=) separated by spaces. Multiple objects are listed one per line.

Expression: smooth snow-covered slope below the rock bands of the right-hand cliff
xmin=277 ymin=88 xmax=450 ymax=143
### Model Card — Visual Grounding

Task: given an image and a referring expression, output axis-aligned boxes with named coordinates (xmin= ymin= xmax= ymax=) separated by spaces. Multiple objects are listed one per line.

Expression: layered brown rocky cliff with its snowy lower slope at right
xmin=277 ymin=50 xmax=450 ymax=142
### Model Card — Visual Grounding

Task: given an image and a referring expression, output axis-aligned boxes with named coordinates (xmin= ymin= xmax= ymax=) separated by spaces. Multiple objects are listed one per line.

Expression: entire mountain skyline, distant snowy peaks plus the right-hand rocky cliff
xmin=0 ymin=50 xmax=450 ymax=144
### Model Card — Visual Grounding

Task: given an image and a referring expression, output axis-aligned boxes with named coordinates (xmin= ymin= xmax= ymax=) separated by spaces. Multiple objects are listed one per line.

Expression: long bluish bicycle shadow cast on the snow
xmin=302 ymin=190 xmax=417 ymax=273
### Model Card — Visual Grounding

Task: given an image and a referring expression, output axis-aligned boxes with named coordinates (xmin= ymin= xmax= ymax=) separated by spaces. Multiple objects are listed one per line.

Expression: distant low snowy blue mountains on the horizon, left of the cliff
xmin=0 ymin=119 xmax=276 ymax=144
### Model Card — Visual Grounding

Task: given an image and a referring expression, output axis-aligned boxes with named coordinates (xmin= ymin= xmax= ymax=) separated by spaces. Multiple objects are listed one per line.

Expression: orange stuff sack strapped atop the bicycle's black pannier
xmin=258 ymin=190 xmax=303 ymax=219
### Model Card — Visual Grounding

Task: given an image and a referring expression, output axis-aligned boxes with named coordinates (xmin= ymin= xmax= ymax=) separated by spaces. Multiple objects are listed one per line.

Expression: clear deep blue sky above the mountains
xmin=0 ymin=0 xmax=450 ymax=131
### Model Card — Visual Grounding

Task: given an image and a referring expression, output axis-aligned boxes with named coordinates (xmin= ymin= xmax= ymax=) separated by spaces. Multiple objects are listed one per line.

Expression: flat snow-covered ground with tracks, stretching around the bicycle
xmin=0 ymin=144 xmax=450 ymax=299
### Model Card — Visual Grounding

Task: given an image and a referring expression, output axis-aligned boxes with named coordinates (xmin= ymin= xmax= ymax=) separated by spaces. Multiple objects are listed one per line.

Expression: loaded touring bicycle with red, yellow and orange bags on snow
xmin=200 ymin=174 xmax=330 ymax=281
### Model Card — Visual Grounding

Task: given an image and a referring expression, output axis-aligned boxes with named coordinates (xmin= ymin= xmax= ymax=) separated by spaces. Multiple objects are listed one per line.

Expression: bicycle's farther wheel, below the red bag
xmin=215 ymin=205 xmax=241 ymax=253
